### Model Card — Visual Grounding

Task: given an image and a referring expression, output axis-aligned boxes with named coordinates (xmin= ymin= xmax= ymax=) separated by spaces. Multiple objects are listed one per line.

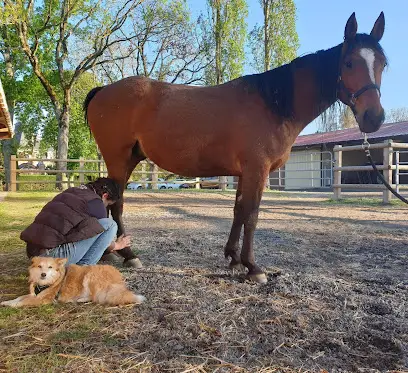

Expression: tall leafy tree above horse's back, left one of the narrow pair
xmin=204 ymin=0 xmax=248 ymax=84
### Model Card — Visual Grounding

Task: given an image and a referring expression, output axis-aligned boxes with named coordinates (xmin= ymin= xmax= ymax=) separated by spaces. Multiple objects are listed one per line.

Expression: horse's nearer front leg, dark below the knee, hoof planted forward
xmin=240 ymin=168 xmax=269 ymax=283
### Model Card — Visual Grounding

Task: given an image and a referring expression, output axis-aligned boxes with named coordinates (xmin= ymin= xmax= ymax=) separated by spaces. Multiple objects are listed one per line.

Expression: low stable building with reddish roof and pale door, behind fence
xmin=280 ymin=122 xmax=408 ymax=190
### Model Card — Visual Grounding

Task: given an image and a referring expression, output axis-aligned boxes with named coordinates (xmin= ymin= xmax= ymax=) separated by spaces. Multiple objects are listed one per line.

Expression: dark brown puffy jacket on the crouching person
xmin=20 ymin=187 xmax=104 ymax=258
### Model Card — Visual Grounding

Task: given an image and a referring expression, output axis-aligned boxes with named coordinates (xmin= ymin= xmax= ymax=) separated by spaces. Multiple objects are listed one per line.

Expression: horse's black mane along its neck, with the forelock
xmin=241 ymin=34 xmax=385 ymax=119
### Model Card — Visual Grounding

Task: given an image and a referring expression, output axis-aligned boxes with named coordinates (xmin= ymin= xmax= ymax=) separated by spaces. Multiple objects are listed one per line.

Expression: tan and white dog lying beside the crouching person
xmin=0 ymin=256 xmax=145 ymax=307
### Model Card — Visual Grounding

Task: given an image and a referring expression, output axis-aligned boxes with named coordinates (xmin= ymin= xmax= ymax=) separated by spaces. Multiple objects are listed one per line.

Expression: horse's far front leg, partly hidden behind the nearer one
xmin=224 ymin=177 xmax=244 ymax=269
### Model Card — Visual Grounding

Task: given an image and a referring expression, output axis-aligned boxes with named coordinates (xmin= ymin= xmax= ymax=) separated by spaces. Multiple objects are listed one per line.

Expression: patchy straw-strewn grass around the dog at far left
xmin=0 ymin=192 xmax=146 ymax=373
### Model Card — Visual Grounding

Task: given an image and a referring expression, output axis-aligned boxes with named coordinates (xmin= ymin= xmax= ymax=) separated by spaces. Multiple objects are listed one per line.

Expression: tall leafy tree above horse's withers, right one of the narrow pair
xmin=249 ymin=0 xmax=299 ymax=72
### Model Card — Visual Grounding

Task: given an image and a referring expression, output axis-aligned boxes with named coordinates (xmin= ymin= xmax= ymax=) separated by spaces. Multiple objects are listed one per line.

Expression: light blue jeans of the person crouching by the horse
xmin=42 ymin=218 xmax=118 ymax=265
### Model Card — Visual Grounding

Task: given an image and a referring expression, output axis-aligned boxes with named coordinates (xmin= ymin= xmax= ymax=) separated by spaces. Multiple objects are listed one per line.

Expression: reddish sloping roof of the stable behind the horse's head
xmin=293 ymin=122 xmax=408 ymax=147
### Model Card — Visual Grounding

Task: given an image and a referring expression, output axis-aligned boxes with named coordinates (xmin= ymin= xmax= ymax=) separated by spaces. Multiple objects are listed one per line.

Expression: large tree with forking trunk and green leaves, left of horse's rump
xmin=5 ymin=0 xmax=142 ymax=186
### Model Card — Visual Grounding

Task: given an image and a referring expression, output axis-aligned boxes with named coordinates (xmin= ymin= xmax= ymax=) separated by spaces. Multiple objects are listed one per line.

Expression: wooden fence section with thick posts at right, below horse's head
xmin=333 ymin=140 xmax=408 ymax=203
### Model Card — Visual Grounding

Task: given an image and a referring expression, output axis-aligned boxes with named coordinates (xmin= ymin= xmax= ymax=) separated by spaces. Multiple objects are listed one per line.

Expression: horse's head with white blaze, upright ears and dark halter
xmin=338 ymin=12 xmax=387 ymax=133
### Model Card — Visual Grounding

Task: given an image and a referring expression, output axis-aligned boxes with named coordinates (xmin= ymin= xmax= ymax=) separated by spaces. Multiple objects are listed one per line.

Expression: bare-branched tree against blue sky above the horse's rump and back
xmin=97 ymin=0 xmax=210 ymax=84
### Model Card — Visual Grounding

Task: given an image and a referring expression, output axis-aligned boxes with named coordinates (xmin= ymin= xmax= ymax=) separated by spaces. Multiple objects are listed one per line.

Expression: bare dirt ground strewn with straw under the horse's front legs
xmin=99 ymin=192 xmax=408 ymax=372
